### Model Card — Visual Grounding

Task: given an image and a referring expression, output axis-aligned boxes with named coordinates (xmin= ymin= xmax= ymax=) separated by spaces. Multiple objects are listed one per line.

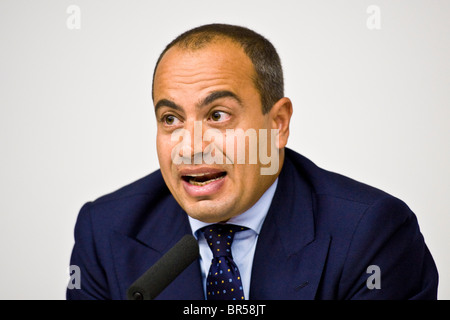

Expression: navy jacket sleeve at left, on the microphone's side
xmin=66 ymin=203 xmax=110 ymax=300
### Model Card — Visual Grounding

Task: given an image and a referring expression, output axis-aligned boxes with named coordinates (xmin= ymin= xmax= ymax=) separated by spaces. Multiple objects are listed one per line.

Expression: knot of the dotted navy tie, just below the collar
xmin=203 ymin=224 xmax=248 ymax=258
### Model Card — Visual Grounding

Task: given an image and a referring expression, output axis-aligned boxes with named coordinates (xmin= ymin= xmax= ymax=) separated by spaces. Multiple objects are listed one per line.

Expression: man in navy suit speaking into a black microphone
xmin=67 ymin=24 xmax=438 ymax=300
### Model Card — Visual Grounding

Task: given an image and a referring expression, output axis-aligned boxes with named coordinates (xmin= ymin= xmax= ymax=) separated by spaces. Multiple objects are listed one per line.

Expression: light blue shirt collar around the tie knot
xmin=188 ymin=178 xmax=278 ymax=238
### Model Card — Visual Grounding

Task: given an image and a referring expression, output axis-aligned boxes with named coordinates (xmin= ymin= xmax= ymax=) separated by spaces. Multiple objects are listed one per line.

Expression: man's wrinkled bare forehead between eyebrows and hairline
xmin=154 ymin=39 xmax=255 ymax=100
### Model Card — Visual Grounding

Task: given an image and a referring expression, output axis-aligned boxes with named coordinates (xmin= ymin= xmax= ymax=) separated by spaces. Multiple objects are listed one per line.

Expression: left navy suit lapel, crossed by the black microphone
xmin=111 ymin=197 xmax=204 ymax=300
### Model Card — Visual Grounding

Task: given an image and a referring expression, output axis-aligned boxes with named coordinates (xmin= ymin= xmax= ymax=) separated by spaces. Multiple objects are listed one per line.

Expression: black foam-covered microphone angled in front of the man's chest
xmin=127 ymin=234 xmax=200 ymax=300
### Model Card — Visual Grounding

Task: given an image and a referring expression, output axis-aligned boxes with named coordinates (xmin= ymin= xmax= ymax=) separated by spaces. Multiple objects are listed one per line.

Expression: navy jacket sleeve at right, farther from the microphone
xmin=339 ymin=197 xmax=438 ymax=300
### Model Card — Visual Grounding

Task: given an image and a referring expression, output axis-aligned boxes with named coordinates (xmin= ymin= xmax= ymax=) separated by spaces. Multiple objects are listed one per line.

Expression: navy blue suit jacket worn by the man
xmin=67 ymin=149 xmax=438 ymax=299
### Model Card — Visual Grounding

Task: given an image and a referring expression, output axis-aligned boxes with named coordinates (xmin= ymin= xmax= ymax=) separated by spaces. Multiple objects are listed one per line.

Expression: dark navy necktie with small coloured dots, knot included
xmin=203 ymin=224 xmax=248 ymax=300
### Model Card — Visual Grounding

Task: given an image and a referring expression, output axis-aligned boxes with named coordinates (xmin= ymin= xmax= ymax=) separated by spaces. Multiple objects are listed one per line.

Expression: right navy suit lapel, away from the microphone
xmin=250 ymin=158 xmax=330 ymax=300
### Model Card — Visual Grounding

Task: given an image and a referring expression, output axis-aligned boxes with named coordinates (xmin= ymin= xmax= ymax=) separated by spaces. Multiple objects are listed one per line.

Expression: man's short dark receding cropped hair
xmin=152 ymin=24 xmax=284 ymax=114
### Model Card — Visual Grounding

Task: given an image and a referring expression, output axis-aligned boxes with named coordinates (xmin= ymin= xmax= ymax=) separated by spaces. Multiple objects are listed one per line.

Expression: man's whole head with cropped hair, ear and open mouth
xmin=153 ymin=25 xmax=292 ymax=222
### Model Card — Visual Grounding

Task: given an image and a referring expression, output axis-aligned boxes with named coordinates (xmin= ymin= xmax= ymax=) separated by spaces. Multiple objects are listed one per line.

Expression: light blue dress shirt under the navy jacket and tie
xmin=188 ymin=178 xmax=278 ymax=299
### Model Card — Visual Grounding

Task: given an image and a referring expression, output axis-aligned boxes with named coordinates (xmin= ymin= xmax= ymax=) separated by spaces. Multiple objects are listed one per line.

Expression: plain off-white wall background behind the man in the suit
xmin=0 ymin=0 xmax=450 ymax=299
